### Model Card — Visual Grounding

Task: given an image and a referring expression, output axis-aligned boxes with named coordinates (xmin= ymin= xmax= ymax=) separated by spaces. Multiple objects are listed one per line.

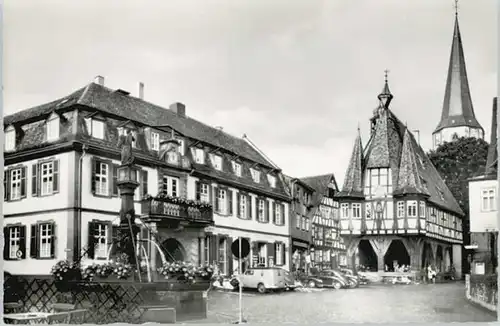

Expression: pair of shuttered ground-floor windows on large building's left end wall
xmin=3 ymin=222 xmax=55 ymax=260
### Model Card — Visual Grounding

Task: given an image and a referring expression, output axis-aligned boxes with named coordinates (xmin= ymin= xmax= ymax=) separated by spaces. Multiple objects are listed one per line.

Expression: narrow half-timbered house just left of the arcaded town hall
xmin=301 ymin=174 xmax=347 ymax=269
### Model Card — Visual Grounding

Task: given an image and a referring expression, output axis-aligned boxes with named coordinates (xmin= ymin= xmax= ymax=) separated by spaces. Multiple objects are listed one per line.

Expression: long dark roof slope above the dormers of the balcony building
xmin=4 ymin=83 xmax=274 ymax=169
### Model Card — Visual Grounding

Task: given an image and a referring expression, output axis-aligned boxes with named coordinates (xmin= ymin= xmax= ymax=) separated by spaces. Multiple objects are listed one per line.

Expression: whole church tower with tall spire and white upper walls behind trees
xmin=432 ymin=0 xmax=484 ymax=149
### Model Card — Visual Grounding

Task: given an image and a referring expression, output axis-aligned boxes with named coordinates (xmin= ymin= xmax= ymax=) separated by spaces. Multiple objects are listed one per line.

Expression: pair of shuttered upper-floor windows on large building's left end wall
xmin=3 ymin=159 xmax=59 ymax=201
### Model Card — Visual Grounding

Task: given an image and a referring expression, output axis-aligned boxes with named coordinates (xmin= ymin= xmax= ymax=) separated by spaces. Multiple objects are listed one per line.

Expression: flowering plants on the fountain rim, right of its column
xmin=158 ymin=262 xmax=214 ymax=283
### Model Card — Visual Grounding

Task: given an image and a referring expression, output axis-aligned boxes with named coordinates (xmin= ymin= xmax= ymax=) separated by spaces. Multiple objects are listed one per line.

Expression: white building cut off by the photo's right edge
xmin=466 ymin=98 xmax=498 ymax=275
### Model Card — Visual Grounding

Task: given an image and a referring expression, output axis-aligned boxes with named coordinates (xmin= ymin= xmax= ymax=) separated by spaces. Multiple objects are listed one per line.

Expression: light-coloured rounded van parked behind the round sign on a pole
xmin=230 ymin=267 xmax=288 ymax=293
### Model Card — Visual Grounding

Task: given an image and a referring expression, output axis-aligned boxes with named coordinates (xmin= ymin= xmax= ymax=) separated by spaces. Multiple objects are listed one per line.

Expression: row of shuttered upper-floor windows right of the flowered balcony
xmin=209 ymin=183 xmax=285 ymax=225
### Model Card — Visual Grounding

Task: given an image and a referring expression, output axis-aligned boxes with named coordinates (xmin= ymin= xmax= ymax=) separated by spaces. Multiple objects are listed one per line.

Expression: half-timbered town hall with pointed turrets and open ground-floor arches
xmin=336 ymin=79 xmax=464 ymax=278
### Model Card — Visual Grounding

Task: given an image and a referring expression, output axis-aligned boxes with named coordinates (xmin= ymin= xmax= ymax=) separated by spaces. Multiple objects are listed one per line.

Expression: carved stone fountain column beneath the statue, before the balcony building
xmin=116 ymin=164 xmax=140 ymax=271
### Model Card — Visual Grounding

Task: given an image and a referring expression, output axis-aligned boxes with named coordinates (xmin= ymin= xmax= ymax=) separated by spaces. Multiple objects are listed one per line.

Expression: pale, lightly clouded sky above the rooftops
xmin=3 ymin=0 xmax=498 ymax=187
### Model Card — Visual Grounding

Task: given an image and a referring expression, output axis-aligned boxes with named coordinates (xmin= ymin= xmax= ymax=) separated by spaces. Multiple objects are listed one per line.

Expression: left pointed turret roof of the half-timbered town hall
xmin=338 ymin=127 xmax=364 ymax=197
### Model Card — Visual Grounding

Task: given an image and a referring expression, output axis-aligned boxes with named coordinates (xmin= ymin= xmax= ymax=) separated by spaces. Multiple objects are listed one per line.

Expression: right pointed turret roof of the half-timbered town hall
xmin=394 ymin=128 xmax=429 ymax=196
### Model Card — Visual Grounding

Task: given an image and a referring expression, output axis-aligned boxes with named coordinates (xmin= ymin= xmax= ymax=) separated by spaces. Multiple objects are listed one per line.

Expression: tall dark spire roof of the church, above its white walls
xmin=434 ymin=14 xmax=483 ymax=133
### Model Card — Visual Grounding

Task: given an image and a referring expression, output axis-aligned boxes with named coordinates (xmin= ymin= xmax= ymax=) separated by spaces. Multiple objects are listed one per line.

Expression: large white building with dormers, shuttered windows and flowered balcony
xmin=4 ymin=77 xmax=290 ymax=274
